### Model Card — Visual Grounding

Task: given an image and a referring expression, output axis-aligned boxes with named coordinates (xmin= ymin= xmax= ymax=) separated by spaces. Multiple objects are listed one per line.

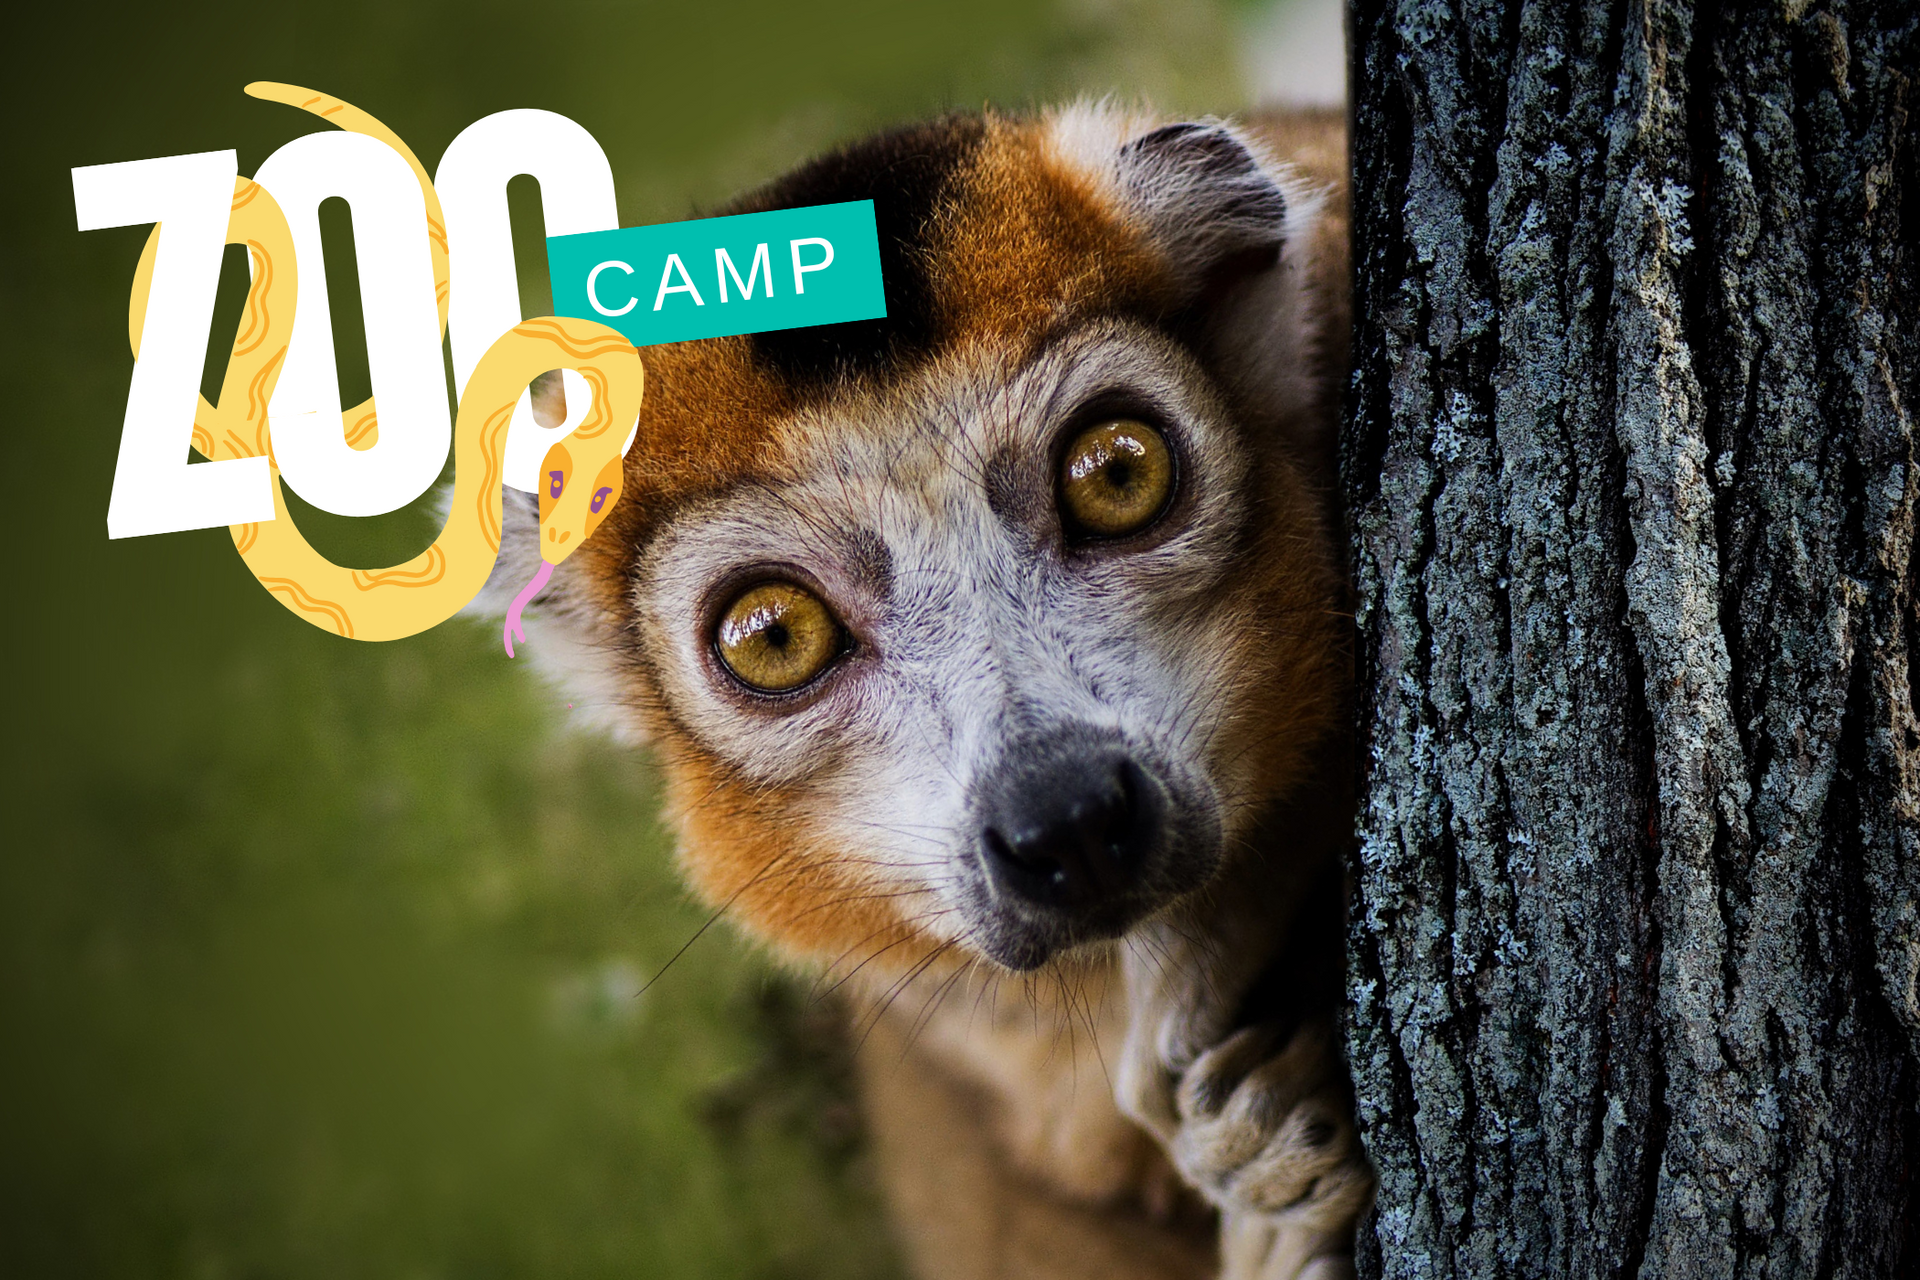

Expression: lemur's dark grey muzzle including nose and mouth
xmin=973 ymin=723 xmax=1187 ymax=969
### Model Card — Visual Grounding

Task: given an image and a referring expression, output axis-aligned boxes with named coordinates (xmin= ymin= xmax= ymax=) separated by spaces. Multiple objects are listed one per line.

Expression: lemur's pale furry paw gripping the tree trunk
xmin=1114 ymin=867 xmax=1373 ymax=1280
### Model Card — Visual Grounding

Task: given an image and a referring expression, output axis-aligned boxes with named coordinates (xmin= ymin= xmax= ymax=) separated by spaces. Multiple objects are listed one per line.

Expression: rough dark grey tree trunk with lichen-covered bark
xmin=1342 ymin=0 xmax=1920 ymax=1280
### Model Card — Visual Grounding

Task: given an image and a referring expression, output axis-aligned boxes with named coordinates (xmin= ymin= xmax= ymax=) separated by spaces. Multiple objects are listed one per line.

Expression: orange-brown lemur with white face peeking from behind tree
xmin=480 ymin=104 xmax=1373 ymax=1280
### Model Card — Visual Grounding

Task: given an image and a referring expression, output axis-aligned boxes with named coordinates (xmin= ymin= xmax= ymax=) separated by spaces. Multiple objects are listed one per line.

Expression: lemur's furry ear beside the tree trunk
xmin=1108 ymin=121 xmax=1346 ymax=457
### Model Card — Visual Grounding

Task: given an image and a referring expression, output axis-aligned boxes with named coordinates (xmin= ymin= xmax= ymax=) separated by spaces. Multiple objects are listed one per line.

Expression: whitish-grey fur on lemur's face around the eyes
xmin=634 ymin=320 xmax=1246 ymax=951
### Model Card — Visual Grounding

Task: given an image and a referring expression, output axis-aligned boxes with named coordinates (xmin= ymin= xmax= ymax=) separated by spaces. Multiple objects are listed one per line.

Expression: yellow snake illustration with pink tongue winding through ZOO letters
xmin=127 ymin=83 xmax=645 ymax=656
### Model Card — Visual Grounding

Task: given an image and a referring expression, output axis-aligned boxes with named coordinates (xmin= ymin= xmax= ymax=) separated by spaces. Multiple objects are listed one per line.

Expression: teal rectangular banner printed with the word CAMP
xmin=547 ymin=200 xmax=887 ymax=347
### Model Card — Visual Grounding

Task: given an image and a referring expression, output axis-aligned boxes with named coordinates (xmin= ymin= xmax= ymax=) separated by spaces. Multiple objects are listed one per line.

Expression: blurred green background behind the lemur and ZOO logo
xmin=0 ymin=0 xmax=1290 ymax=1280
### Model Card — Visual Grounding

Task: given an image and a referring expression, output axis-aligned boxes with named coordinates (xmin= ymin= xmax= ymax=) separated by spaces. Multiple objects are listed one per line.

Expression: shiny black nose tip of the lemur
xmin=983 ymin=758 xmax=1154 ymax=910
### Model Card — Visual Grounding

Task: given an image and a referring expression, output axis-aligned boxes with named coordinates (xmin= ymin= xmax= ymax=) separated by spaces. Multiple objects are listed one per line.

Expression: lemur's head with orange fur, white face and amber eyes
xmin=510 ymin=109 xmax=1344 ymax=969
